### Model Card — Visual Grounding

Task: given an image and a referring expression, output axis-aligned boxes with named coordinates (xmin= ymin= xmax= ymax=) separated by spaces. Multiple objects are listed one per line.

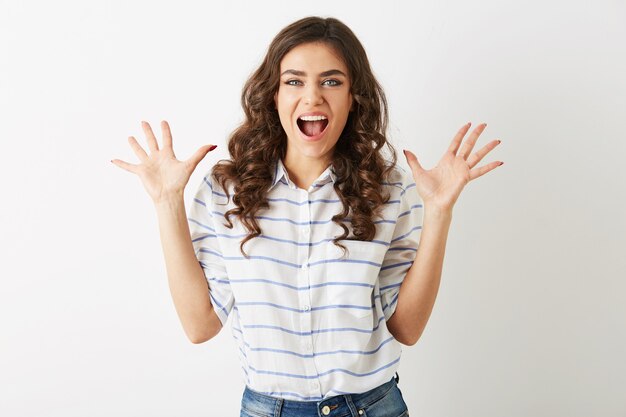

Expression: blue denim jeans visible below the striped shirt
xmin=239 ymin=373 xmax=409 ymax=417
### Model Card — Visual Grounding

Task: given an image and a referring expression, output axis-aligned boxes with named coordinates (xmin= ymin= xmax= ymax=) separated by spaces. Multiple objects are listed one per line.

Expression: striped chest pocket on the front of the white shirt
xmin=325 ymin=240 xmax=386 ymax=319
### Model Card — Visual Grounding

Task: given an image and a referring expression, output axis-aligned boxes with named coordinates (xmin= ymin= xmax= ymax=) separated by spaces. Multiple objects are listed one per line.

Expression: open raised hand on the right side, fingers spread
xmin=404 ymin=123 xmax=503 ymax=210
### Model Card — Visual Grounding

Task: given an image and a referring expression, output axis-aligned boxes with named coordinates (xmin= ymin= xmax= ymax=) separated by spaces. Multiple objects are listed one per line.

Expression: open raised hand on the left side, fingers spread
xmin=111 ymin=120 xmax=215 ymax=204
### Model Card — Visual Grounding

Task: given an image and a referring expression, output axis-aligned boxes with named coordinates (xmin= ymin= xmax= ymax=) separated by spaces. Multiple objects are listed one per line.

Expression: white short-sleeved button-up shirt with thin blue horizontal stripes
xmin=188 ymin=159 xmax=423 ymax=401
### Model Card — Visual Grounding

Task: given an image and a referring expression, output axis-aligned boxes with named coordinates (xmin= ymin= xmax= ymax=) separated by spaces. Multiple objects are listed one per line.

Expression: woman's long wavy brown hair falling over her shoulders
xmin=212 ymin=16 xmax=397 ymax=258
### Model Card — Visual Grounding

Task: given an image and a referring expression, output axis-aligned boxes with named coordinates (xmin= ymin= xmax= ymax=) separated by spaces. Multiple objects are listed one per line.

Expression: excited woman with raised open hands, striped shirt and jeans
xmin=113 ymin=17 xmax=501 ymax=417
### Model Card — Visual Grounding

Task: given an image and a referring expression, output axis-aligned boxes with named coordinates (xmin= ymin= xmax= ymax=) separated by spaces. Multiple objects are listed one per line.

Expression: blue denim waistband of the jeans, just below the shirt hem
xmin=242 ymin=373 xmax=400 ymax=416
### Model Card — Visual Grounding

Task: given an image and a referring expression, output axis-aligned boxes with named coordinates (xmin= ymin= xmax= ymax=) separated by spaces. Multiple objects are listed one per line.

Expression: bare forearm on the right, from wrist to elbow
xmin=387 ymin=206 xmax=452 ymax=345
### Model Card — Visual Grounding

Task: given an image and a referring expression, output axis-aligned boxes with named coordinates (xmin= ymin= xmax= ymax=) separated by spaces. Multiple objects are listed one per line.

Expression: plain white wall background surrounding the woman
xmin=0 ymin=0 xmax=626 ymax=417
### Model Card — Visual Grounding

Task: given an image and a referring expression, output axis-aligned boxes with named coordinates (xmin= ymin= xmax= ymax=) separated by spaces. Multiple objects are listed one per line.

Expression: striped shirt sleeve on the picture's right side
xmin=379 ymin=168 xmax=424 ymax=320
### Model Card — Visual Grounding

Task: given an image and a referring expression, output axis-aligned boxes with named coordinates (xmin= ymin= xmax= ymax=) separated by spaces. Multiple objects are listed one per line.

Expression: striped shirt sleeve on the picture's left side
xmin=187 ymin=173 xmax=235 ymax=326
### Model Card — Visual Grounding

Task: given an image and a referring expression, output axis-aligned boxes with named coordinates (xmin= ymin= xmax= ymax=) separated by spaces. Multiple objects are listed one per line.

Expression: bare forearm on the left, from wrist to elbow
xmin=155 ymin=194 xmax=221 ymax=343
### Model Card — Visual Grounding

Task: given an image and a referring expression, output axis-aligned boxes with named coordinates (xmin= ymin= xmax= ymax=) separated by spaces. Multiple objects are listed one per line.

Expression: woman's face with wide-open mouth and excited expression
xmin=274 ymin=43 xmax=352 ymax=159
